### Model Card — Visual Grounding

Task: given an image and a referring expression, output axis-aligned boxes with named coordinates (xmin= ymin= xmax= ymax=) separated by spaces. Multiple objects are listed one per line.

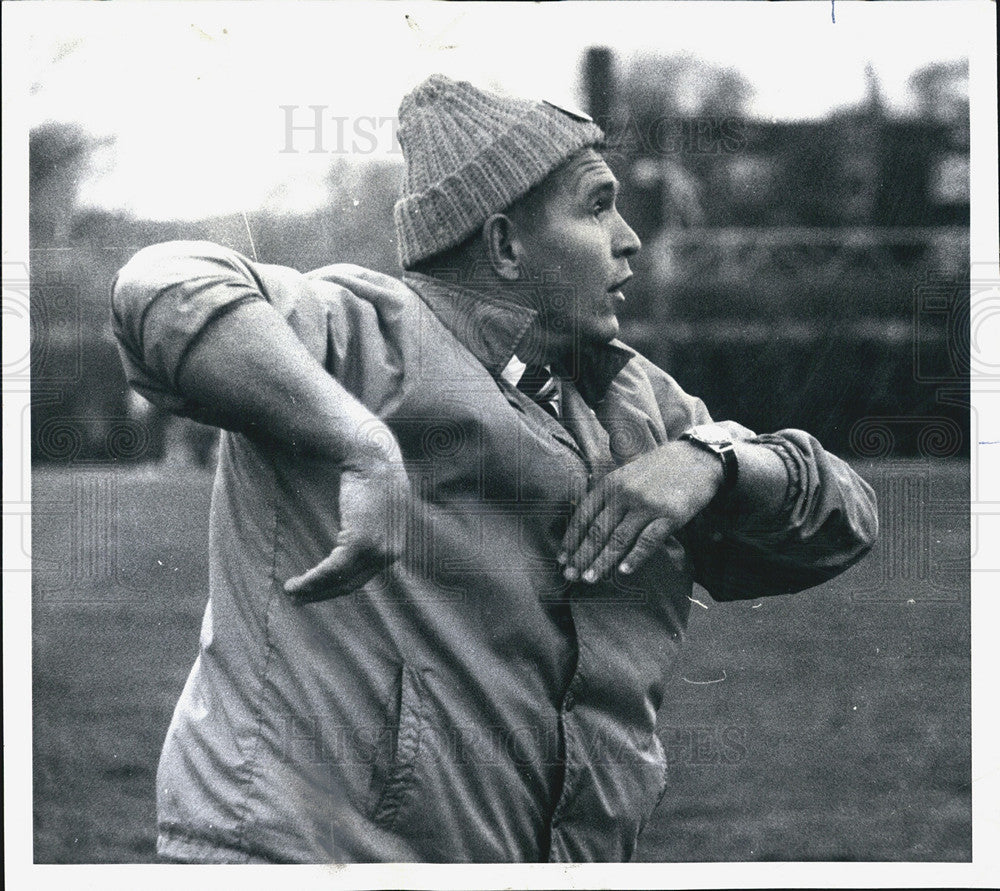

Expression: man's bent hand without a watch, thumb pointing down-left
xmin=285 ymin=428 xmax=411 ymax=603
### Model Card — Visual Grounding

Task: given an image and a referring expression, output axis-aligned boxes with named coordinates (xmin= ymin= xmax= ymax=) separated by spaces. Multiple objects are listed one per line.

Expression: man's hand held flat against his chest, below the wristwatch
xmin=559 ymin=442 xmax=722 ymax=582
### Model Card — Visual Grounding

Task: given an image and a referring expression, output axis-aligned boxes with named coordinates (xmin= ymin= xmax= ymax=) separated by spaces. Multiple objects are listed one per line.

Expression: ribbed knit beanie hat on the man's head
xmin=393 ymin=74 xmax=604 ymax=269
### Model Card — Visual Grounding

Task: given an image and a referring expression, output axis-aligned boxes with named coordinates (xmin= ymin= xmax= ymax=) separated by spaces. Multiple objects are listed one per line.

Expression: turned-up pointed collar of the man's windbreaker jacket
xmin=403 ymin=272 xmax=634 ymax=405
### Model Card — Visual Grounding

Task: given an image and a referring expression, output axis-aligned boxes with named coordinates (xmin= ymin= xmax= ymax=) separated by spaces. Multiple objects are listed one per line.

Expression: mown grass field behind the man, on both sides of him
xmin=32 ymin=461 xmax=971 ymax=863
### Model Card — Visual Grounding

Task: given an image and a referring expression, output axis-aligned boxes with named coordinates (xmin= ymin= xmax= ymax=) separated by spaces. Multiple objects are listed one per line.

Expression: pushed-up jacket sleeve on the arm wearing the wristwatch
xmin=680 ymin=430 xmax=878 ymax=601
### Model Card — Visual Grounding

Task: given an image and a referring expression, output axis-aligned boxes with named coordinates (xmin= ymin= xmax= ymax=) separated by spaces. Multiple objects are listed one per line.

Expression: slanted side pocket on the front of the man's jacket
xmin=372 ymin=664 xmax=427 ymax=829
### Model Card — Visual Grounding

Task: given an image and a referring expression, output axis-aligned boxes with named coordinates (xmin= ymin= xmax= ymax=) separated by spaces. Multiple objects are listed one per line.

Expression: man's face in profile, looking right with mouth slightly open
xmin=513 ymin=149 xmax=641 ymax=362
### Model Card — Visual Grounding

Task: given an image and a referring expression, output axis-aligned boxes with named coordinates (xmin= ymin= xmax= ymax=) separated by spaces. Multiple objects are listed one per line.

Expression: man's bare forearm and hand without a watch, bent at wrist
xmin=159 ymin=292 xmax=410 ymax=603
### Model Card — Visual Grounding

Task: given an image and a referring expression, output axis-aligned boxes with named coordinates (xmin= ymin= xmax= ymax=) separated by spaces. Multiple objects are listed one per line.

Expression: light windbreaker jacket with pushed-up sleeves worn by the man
xmin=113 ymin=242 xmax=876 ymax=862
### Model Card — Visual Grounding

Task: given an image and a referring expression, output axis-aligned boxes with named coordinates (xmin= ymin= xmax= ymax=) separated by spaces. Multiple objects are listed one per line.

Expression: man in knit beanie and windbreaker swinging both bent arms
xmin=114 ymin=75 xmax=876 ymax=862
